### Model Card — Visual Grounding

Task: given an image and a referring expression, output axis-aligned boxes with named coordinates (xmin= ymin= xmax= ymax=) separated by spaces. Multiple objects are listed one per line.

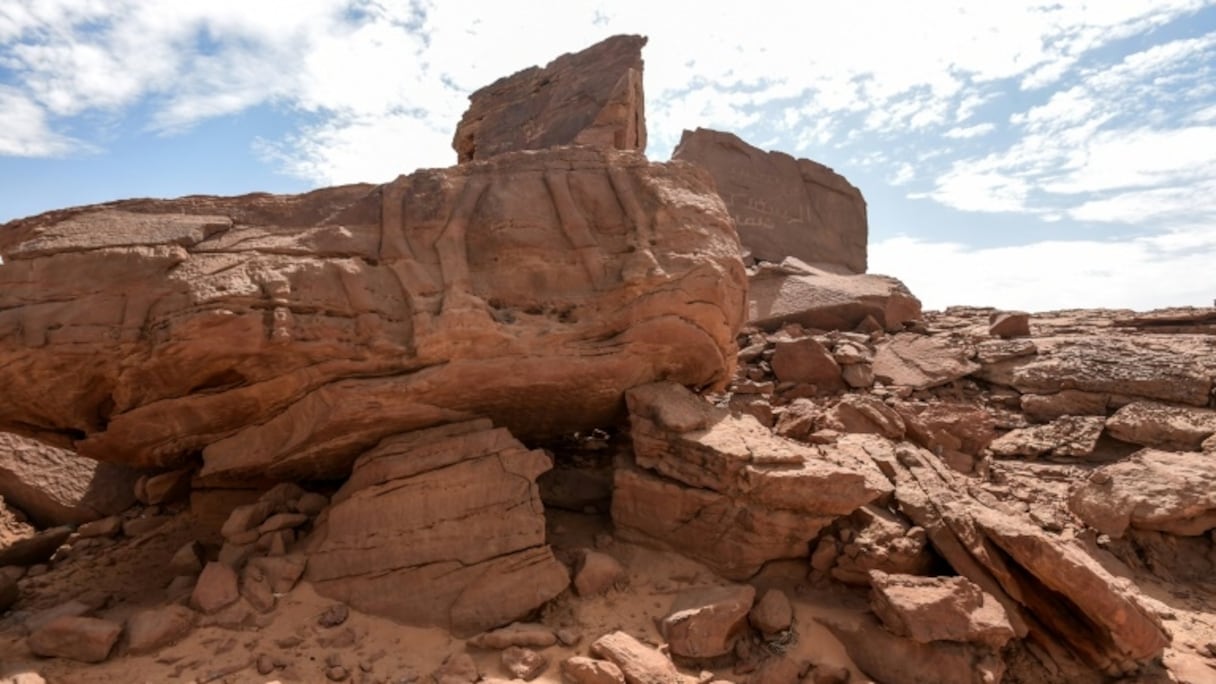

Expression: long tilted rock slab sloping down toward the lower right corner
xmin=890 ymin=438 xmax=1170 ymax=674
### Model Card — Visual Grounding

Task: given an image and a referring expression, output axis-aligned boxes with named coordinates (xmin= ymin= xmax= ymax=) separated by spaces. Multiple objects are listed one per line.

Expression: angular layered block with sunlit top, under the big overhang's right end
xmin=613 ymin=383 xmax=890 ymax=579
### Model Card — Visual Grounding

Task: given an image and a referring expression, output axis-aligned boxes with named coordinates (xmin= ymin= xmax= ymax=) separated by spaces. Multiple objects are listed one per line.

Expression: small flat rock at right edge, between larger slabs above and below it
xmin=1107 ymin=402 xmax=1216 ymax=452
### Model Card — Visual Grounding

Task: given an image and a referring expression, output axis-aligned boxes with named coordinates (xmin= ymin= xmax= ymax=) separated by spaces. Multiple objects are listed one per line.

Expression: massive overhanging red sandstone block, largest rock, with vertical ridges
xmin=0 ymin=147 xmax=744 ymax=480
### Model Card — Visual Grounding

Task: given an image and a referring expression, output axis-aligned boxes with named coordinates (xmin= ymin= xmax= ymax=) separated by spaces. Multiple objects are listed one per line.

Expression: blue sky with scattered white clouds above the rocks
xmin=0 ymin=0 xmax=1216 ymax=310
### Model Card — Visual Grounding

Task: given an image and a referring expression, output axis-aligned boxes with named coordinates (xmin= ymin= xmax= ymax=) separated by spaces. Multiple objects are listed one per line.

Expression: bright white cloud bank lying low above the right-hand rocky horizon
xmin=869 ymin=232 xmax=1216 ymax=312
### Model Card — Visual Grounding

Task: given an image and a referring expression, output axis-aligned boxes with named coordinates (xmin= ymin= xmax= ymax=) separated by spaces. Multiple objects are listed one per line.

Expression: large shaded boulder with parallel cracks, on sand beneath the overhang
xmin=308 ymin=420 xmax=569 ymax=635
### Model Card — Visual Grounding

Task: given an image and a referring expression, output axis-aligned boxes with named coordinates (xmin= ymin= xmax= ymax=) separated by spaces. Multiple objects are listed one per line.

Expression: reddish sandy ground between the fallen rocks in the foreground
xmin=0 ymin=503 xmax=869 ymax=684
